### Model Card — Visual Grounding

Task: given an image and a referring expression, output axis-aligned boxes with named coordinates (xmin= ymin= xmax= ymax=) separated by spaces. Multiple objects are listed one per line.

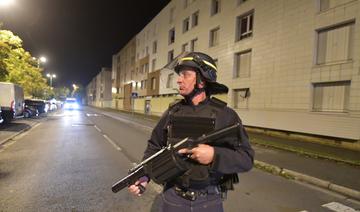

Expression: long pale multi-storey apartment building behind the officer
xmin=113 ymin=0 xmax=360 ymax=141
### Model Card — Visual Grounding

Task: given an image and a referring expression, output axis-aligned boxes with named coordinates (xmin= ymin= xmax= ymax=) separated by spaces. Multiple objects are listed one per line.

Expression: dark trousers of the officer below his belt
xmin=160 ymin=186 xmax=224 ymax=212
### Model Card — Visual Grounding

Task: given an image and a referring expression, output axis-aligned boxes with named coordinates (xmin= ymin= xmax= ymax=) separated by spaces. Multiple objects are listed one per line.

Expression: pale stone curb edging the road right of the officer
xmin=254 ymin=160 xmax=360 ymax=200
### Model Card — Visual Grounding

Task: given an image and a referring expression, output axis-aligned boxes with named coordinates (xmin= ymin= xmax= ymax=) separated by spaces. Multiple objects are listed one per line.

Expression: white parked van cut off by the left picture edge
xmin=0 ymin=82 xmax=24 ymax=123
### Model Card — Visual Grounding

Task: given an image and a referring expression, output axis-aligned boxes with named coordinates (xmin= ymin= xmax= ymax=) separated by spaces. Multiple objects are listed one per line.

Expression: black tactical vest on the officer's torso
xmin=167 ymin=98 xmax=226 ymax=187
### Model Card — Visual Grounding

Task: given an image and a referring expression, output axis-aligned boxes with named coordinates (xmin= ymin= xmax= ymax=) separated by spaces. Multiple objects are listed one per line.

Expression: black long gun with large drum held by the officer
xmin=111 ymin=123 xmax=240 ymax=193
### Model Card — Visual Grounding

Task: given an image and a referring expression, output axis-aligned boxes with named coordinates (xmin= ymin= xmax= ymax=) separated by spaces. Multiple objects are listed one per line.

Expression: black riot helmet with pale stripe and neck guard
xmin=174 ymin=52 xmax=229 ymax=94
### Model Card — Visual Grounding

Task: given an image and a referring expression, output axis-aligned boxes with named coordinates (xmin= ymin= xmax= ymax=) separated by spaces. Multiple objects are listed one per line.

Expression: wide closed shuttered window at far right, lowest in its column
xmin=313 ymin=81 xmax=350 ymax=112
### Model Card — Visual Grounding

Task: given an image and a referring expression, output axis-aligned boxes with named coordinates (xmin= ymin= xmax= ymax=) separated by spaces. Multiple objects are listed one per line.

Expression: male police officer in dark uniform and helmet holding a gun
xmin=129 ymin=52 xmax=254 ymax=212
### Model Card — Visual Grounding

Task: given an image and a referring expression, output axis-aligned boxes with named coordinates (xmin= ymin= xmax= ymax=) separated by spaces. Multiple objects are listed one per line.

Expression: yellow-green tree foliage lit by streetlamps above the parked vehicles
xmin=0 ymin=29 xmax=54 ymax=98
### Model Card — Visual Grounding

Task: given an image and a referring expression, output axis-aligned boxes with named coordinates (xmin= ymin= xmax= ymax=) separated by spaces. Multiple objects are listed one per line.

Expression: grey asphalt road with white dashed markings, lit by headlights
xmin=0 ymin=109 xmax=360 ymax=212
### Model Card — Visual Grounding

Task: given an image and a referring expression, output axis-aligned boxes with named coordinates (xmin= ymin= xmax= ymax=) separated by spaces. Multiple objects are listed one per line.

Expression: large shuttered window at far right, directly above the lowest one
xmin=316 ymin=22 xmax=354 ymax=64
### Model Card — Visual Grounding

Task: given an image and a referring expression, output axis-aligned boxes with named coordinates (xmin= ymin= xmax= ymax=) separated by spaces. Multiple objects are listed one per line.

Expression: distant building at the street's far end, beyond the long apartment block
xmin=86 ymin=68 xmax=112 ymax=107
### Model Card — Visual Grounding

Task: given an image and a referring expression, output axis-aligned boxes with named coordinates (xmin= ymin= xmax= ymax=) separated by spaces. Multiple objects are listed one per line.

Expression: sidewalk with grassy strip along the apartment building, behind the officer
xmin=89 ymin=108 xmax=360 ymax=199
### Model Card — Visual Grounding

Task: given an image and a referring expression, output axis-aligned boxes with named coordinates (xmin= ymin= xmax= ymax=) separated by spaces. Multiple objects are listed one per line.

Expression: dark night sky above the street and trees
xmin=0 ymin=0 xmax=170 ymax=86
